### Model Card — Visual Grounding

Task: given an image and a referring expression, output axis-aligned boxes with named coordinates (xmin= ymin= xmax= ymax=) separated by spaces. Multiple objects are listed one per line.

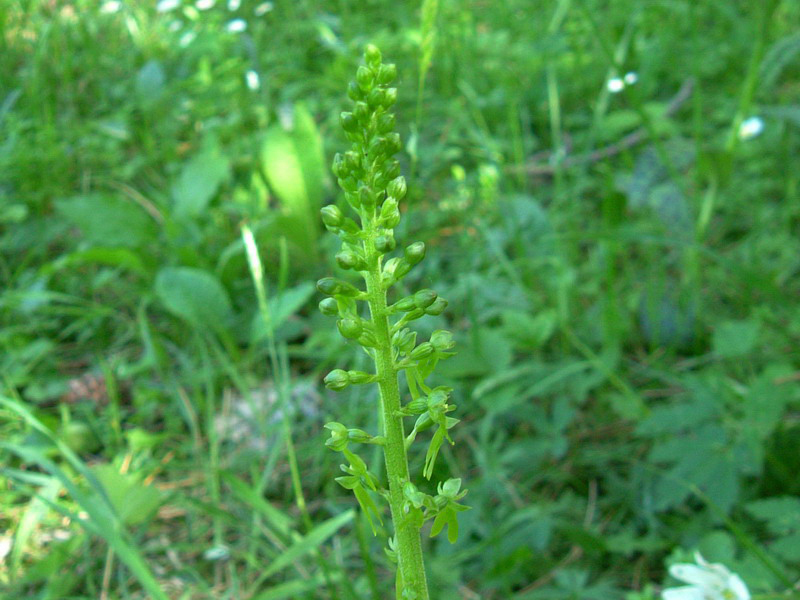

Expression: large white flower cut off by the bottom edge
xmin=661 ymin=552 xmax=750 ymax=600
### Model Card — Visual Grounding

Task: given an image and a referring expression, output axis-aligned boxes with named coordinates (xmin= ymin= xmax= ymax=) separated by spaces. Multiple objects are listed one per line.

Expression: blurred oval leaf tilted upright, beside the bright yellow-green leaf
xmin=172 ymin=144 xmax=230 ymax=217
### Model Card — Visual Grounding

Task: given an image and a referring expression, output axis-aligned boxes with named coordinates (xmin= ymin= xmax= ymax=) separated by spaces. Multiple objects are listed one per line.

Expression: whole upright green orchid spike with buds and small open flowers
xmin=317 ymin=45 xmax=468 ymax=600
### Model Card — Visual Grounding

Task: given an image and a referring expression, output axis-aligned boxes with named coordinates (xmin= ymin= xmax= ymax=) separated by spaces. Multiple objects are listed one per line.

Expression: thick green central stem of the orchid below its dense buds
xmin=366 ymin=251 xmax=429 ymax=600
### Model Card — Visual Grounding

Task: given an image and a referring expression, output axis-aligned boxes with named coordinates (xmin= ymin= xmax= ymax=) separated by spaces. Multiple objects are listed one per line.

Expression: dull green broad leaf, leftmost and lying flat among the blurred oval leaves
xmin=55 ymin=194 xmax=156 ymax=248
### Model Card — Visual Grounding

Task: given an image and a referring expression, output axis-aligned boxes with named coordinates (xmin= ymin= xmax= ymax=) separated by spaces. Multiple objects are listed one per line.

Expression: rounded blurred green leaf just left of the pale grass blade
xmin=155 ymin=267 xmax=233 ymax=328
